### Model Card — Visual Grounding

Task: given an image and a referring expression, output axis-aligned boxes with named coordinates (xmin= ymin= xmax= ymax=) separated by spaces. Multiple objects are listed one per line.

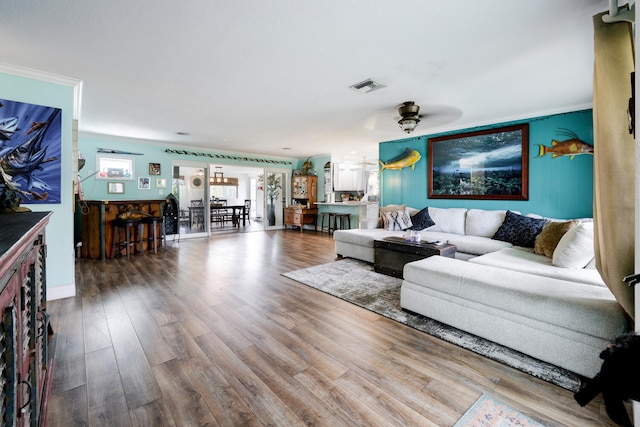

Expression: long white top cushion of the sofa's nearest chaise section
xmin=403 ymin=254 xmax=625 ymax=339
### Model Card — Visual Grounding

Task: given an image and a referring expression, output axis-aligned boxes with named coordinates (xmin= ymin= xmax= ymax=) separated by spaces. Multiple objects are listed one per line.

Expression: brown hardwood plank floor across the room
xmin=48 ymin=230 xmax=614 ymax=427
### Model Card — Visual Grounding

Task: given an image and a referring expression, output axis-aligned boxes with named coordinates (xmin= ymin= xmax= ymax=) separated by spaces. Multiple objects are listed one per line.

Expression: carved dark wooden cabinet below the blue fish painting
xmin=0 ymin=212 xmax=53 ymax=426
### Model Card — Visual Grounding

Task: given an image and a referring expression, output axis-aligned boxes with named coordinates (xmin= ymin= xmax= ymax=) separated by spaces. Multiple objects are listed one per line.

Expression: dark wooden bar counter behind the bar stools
xmin=78 ymin=199 xmax=166 ymax=259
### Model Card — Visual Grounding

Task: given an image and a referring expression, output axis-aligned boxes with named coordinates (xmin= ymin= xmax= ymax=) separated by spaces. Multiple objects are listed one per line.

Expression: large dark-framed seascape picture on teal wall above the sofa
xmin=428 ymin=124 xmax=529 ymax=200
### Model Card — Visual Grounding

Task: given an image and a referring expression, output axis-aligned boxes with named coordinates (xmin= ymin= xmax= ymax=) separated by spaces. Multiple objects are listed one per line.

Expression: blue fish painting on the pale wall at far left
xmin=0 ymin=99 xmax=62 ymax=204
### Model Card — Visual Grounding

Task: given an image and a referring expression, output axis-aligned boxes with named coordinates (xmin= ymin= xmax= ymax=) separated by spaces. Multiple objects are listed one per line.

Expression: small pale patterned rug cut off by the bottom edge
xmin=453 ymin=394 xmax=545 ymax=427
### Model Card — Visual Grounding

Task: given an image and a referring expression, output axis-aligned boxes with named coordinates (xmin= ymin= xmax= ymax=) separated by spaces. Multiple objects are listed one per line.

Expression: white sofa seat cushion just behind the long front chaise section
xmin=469 ymin=247 xmax=604 ymax=286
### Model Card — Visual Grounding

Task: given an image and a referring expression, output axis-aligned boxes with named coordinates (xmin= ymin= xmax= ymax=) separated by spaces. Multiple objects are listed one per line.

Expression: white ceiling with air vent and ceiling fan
xmin=0 ymin=0 xmax=622 ymax=163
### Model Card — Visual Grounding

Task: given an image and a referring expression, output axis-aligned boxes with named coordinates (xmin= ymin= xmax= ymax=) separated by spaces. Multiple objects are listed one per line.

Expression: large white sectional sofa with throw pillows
xmin=334 ymin=206 xmax=629 ymax=377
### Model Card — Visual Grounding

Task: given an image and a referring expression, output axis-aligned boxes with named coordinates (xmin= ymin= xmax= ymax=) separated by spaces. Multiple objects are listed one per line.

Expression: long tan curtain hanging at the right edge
xmin=593 ymin=13 xmax=635 ymax=318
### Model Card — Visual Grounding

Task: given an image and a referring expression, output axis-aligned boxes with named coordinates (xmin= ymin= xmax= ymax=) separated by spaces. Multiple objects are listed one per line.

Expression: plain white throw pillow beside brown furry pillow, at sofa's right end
xmin=552 ymin=222 xmax=595 ymax=268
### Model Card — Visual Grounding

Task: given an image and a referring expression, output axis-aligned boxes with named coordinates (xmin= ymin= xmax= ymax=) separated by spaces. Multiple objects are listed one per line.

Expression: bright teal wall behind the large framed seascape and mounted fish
xmin=379 ymin=110 xmax=593 ymax=218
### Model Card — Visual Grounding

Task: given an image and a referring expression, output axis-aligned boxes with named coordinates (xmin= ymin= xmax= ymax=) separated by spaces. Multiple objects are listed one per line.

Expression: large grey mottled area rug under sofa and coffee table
xmin=282 ymin=258 xmax=581 ymax=392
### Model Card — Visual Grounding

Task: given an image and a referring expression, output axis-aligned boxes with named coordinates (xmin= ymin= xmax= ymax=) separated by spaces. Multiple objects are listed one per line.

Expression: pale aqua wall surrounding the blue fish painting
xmin=0 ymin=73 xmax=75 ymax=295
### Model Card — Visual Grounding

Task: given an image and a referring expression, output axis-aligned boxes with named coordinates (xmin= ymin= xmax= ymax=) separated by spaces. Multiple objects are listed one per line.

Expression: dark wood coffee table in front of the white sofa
xmin=373 ymin=237 xmax=456 ymax=279
